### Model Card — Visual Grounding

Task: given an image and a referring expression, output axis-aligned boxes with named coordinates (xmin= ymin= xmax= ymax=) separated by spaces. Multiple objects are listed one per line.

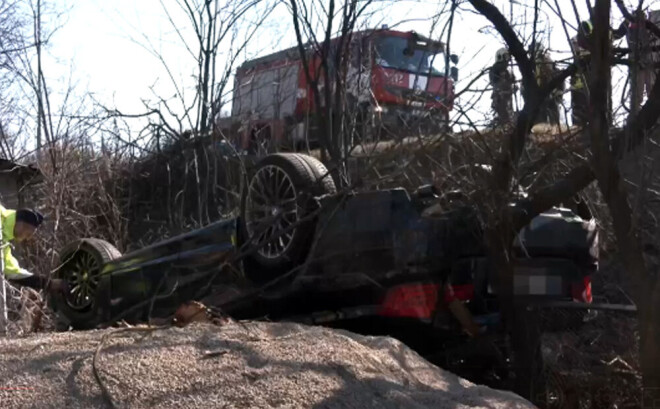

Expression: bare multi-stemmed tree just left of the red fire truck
xmin=102 ymin=0 xmax=276 ymax=230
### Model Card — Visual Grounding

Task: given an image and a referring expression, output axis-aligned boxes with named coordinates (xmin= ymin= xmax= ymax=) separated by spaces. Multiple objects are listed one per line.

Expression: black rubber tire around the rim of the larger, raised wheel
xmin=239 ymin=153 xmax=336 ymax=279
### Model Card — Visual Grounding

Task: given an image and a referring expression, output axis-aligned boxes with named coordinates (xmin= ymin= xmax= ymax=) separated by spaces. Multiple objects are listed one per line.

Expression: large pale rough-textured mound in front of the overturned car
xmin=0 ymin=323 xmax=533 ymax=409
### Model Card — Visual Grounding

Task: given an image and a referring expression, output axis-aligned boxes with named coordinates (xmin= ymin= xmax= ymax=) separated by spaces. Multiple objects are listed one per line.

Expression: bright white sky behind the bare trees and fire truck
xmin=29 ymin=0 xmax=640 ymax=139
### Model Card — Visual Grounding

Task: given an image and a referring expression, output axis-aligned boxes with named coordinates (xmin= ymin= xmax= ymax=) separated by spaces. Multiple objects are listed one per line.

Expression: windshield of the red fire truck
xmin=374 ymin=36 xmax=445 ymax=75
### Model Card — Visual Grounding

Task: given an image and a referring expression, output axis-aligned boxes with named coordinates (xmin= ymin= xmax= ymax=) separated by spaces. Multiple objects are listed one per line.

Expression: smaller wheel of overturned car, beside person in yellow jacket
xmin=50 ymin=239 xmax=121 ymax=329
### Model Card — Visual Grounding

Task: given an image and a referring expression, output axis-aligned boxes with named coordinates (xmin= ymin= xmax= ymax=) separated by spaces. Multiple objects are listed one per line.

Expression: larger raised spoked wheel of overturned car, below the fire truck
xmin=239 ymin=153 xmax=336 ymax=277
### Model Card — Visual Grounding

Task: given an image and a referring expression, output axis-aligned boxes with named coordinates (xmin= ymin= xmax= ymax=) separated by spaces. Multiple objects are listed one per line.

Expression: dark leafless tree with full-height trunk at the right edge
xmin=589 ymin=0 xmax=660 ymax=407
